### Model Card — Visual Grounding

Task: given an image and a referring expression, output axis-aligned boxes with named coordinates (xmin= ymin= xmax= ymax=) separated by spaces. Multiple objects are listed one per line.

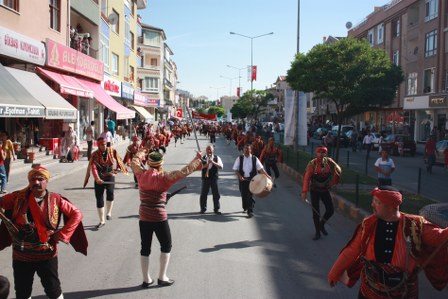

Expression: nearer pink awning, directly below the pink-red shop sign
xmin=36 ymin=67 xmax=93 ymax=98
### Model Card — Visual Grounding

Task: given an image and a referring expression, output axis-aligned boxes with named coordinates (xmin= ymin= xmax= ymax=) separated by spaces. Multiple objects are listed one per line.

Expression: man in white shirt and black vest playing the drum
xmin=232 ymin=144 xmax=271 ymax=218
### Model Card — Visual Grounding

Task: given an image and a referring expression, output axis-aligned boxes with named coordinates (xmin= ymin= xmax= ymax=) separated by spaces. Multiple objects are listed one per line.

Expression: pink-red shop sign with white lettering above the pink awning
xmin=46 ymin=38 xmax=104 ymax=81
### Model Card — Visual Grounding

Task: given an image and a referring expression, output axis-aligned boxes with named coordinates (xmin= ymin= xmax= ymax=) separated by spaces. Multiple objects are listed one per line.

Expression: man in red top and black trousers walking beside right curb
xmin=301 ymin=146 xmax=342 ymax=240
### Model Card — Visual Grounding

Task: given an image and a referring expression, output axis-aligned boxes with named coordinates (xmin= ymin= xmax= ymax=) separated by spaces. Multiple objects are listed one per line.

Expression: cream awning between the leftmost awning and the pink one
xmin=5 ymin=67 xmax=77 ymax=119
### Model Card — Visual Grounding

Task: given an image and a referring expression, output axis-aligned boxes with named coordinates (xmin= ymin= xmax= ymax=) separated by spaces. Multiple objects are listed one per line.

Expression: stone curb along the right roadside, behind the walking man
xmin=278 ymin=163 xmax=370 ymax=223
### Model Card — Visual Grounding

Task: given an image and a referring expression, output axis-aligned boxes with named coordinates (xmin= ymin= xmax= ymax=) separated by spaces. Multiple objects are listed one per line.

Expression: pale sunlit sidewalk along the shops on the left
xmin=6 ymin=139 xmax=129 ymax=191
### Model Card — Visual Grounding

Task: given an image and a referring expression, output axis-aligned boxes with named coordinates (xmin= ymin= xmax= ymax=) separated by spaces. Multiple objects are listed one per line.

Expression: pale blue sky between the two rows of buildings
xmin=138 ymin=0 xmax=391 ymax=101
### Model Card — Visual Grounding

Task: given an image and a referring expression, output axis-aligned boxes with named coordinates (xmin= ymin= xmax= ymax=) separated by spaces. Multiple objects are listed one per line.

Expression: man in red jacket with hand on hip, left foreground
xmin=0 ymin=167 xmax=87 ymax=298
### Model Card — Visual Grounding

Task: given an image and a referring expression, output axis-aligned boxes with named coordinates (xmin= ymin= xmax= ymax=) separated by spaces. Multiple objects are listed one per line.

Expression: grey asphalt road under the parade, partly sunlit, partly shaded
xmin=0 ymin=136 xmax=447 ymax=299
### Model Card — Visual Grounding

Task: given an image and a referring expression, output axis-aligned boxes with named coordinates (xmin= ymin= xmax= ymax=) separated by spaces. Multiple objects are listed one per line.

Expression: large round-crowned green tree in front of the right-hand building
xmin=286 ymin=38 xmax=404 ymax=163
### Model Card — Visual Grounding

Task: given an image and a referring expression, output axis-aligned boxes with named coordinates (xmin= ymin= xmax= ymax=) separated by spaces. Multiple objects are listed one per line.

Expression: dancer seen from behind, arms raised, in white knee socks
xmin=131 ymin=148 xmax=202 ymax=288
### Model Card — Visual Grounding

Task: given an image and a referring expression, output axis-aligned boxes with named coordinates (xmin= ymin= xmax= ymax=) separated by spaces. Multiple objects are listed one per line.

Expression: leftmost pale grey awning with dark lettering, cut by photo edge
xmin=0 ymin=64 xmax=45 ymax=117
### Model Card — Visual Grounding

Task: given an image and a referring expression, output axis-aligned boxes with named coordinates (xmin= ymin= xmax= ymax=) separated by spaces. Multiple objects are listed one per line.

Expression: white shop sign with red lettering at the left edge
xmin=0 ymin=27 xmax=45 ymax=65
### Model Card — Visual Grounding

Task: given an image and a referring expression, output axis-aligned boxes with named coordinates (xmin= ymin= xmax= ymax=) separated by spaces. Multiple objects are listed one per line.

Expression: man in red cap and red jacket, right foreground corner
xmin=328 ymin=186 xmax=448 ymax=299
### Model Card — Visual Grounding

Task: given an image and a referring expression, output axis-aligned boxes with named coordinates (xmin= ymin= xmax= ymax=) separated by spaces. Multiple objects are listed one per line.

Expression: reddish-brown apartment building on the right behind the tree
xmin=348 ymin=0 xmax=448 ymax=141
